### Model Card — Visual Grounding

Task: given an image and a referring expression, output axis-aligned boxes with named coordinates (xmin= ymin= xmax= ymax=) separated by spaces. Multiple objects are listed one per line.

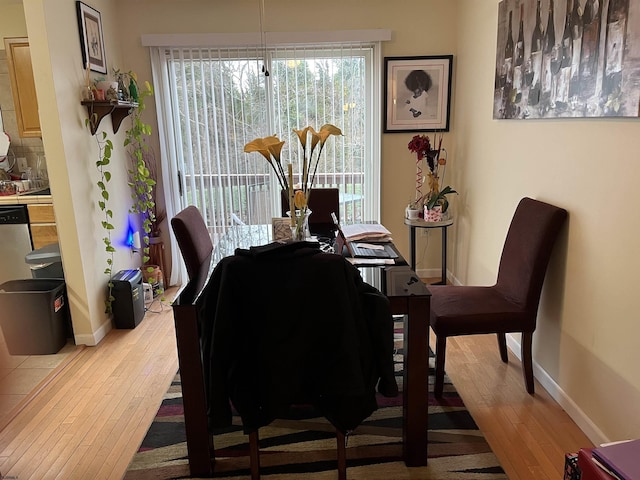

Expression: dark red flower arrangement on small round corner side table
xmin=408 ymin=135 xmax=458 ymax=219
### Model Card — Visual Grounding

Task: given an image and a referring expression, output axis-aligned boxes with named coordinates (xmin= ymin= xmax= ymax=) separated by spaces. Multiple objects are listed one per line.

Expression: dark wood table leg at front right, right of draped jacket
xmin=403 ymin=296 xmax=431 ymax=467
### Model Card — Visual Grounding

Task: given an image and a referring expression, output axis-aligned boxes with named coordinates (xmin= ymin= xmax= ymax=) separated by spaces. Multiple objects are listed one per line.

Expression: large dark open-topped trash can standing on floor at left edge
xmin=0 ymin=278 xmax=70 ymax=355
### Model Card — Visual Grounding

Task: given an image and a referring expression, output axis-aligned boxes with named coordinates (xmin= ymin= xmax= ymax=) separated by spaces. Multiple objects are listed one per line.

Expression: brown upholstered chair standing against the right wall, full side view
xmin=429 ymin=198 xmax=567 ymax=397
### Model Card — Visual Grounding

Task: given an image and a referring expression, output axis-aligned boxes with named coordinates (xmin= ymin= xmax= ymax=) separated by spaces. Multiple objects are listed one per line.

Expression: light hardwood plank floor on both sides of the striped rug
xmin=0 ymin=290 xmax=591 ymax=480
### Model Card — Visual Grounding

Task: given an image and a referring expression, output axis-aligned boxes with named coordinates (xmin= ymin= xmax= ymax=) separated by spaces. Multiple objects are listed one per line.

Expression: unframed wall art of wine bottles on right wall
xmin=493 ymin=0 xmax=640 ymax=119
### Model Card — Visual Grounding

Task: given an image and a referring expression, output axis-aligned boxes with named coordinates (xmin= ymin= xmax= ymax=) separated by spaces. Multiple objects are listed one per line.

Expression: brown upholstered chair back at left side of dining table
xmin=171 ymin=205 xmax=213 ymax=279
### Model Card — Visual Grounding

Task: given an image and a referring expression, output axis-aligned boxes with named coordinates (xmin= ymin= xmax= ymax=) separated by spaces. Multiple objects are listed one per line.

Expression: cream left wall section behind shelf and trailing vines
xmin=24 ymin=0 xmax=140 ymax=345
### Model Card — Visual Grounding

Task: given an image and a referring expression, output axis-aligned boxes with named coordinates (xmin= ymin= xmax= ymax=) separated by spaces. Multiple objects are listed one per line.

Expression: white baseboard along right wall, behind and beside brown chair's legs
xmin=507 ymin=334 xmax=611 ymax=445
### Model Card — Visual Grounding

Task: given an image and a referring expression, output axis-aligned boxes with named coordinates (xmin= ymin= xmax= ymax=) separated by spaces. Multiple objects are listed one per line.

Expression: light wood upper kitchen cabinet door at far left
xmin=4 ymin=38 xmax=42 ymax=138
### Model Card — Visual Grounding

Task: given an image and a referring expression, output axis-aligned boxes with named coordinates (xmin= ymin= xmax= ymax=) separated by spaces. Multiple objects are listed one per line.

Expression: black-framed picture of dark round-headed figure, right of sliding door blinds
xmin=383 ymin=55 xmax=453 ymax=133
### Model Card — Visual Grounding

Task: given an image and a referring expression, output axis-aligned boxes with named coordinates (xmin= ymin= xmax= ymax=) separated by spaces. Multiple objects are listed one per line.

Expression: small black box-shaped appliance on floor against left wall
xmin=111 ymin=269 xmax=144 ymax=328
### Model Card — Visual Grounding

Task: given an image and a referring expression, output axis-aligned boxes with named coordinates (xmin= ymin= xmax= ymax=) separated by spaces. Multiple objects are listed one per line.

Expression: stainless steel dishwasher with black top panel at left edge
xmin=0 ymin=205 xmax=33 ymax=284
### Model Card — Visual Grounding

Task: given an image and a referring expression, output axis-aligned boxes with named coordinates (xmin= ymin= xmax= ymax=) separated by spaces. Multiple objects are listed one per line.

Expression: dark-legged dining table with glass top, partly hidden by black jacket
xmin=173 ymin=225 xmax=431 ymax=476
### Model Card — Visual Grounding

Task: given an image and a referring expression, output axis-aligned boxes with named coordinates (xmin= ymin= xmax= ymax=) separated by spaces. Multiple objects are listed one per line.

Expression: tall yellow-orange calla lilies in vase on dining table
xmin=244 ymin=123 xmax=342 ymax=239
